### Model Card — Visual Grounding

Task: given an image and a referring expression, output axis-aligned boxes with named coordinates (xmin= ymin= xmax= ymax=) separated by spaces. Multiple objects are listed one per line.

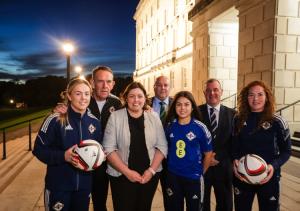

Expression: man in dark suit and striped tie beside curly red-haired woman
xmin=199 ymin=79 xmax=235 ymax=211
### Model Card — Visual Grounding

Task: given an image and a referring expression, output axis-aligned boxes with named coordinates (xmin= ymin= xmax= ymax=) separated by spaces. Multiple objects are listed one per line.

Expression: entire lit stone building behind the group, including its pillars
xmin=134 ymin=0 xmax=300 ymax=131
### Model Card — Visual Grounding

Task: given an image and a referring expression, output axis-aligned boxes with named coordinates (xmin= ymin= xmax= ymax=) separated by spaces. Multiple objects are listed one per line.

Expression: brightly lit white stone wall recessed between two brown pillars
xmin=208 ymin=18 xmax=238 ymax=107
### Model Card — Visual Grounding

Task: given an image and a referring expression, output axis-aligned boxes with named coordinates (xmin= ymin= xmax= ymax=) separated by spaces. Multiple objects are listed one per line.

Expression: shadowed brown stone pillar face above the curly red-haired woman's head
xmin=236 ymin=0 xmax=276 ymax=90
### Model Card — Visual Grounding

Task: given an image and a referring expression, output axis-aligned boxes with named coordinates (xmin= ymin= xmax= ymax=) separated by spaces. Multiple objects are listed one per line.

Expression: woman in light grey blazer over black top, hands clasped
xmin=103 ymin=82 xmax=167 ymax=211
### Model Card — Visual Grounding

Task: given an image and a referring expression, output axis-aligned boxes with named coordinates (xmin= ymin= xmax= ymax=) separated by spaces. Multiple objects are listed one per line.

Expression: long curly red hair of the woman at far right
xmin=236 ymin=81 xmax=275 ymax=133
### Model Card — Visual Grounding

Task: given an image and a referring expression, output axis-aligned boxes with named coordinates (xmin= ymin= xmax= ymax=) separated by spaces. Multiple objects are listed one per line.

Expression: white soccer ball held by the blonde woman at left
xmin=74 ymin=139 xmax=105 ymax=171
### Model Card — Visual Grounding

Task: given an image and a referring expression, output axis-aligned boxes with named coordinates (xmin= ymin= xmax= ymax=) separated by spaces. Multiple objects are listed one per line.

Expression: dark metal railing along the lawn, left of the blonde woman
xmin=0 ymin=115 xmax=45 ymax=160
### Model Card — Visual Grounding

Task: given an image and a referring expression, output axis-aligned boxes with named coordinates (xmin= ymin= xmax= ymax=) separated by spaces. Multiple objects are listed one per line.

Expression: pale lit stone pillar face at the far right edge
xmin=274 ymin=0 xmax=300 ymax=131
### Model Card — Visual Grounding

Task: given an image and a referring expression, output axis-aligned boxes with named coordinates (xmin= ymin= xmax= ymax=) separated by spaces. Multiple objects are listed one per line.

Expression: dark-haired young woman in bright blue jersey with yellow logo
xmin=165 ymin=91 xmax=212 ymax=211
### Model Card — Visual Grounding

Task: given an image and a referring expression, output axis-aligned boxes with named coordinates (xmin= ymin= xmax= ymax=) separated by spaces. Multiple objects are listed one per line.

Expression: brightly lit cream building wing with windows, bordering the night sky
xmin=133 ymin=0 xmax=195 ymax=95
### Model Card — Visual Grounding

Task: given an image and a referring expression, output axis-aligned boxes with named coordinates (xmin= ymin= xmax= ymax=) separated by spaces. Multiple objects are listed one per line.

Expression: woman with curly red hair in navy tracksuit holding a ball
xmin=232 ymin=81 xmax=291 ymax=211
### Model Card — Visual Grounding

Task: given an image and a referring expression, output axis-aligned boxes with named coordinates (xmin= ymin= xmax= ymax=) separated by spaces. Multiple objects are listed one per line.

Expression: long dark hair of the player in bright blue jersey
xmin=164 ymin=91 xmax=202 ymax=126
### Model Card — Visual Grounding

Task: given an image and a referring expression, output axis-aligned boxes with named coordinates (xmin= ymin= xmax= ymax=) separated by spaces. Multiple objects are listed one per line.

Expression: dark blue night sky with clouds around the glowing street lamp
xmin=0 ymin=0 xmax=139 ymax=80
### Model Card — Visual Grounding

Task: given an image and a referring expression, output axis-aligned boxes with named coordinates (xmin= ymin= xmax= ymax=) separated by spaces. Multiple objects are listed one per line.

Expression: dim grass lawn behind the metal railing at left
xmin=0 ymin=108 xmax=52 ymax=131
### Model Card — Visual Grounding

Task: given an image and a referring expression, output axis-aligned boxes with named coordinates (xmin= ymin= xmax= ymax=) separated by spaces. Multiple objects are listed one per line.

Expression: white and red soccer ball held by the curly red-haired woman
xmin=237 ymin=154 xmax=268 ymax=184
